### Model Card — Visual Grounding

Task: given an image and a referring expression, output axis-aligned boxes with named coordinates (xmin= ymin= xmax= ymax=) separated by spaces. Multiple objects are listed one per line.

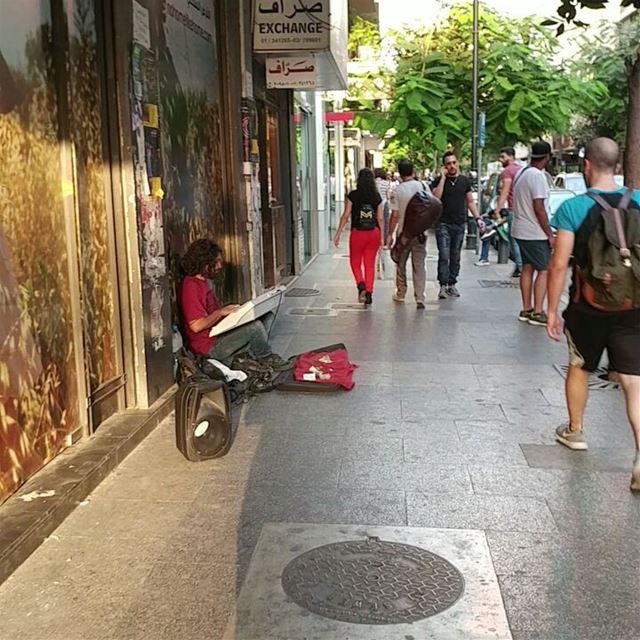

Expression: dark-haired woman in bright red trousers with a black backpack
xmin=333 ymin=169 xmax=384 ymax=304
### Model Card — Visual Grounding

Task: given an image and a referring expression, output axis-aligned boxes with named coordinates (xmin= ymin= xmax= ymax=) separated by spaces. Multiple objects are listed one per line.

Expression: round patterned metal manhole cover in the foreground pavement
xmin=282 ymin=538 xmax=464 ymax=624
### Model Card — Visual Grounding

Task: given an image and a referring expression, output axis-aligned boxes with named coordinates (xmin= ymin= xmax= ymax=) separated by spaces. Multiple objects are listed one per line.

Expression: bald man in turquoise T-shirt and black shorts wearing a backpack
xmin=547 ymin=138 xmax=640 ymax=491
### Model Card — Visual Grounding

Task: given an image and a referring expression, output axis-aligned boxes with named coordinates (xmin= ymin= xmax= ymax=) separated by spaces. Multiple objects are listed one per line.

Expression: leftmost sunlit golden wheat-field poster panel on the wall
xmin=0 ymin=2 xmax=81 ymax=503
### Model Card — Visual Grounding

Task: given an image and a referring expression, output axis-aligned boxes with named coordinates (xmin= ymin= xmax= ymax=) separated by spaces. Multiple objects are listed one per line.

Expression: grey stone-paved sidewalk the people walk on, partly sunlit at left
xmin=0 ymin=245 xmax=640 ymax=640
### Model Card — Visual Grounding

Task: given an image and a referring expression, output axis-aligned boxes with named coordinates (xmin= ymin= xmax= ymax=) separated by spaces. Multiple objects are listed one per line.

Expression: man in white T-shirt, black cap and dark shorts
xmin=512 ymin=141 xmax=554 ymax=327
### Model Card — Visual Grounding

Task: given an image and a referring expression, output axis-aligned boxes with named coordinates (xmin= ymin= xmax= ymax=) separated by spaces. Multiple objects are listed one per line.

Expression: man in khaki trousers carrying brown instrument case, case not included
xmin=386 ymin=159 xmax=428 ymax=309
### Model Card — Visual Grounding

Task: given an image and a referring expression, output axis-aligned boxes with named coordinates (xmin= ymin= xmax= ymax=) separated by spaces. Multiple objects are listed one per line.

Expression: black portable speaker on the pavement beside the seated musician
xmin=176 ymin=376 xmax=232 ymax=462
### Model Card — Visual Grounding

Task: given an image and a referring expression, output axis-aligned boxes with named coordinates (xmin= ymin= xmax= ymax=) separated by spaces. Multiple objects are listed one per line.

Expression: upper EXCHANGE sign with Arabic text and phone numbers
xmin=253 ymin=0 xmax=331 ymax=51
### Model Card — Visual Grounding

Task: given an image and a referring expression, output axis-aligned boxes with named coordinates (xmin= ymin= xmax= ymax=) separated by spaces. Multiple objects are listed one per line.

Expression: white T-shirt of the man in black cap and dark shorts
xmin=511 ymin=167 xmax=549 ymax=240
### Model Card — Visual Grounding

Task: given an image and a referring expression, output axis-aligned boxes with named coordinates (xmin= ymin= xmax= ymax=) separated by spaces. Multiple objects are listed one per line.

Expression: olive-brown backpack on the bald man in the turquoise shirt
xmin=575 ymin=189 xmax=640 ymax=312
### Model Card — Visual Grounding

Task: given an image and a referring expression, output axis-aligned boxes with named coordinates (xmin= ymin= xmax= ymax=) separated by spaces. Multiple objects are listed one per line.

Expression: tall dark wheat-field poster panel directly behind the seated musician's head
xmin=158 ymin=0 xmax=227 ymax=298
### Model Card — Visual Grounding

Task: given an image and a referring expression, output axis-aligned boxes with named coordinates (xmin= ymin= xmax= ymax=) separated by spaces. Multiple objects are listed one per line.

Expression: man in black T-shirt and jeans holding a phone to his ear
xmin=431 ymin=151 xmax=482 ymax=300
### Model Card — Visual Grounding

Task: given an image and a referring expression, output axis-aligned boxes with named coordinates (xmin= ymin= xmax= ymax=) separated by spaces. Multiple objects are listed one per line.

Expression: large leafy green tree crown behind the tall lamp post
xmin=362 ymin=4 xmax=605 ymax=168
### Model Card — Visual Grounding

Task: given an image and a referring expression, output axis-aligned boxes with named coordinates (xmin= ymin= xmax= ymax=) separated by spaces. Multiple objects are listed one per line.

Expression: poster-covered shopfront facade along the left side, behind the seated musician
xmin=0 ymin=0 xmax=348 ymax=502
